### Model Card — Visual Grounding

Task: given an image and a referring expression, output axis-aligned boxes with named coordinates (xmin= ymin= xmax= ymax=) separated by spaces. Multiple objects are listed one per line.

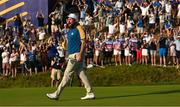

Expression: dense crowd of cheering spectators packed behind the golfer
xmin=0 ymin=0 xmax=180 ymax=77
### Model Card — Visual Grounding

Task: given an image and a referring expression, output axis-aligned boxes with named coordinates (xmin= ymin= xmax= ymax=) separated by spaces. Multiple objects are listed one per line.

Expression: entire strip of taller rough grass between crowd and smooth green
xmin=0 ymin=65 xmax=180 ymax=88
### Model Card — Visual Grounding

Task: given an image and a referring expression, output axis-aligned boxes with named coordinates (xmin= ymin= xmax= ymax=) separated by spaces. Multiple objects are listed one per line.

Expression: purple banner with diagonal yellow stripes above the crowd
xmin=0 ymin=0 xmax=48 ymax=25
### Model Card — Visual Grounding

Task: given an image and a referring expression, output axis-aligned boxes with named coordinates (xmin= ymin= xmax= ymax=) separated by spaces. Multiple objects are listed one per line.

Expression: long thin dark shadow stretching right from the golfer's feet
xmin=96 ymin=89 xmax=180 ymax=100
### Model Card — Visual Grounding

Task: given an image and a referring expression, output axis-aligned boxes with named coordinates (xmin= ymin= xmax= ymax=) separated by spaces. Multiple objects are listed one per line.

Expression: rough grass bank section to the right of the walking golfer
xmin=89 ymin=65 xmax=180 ymax=86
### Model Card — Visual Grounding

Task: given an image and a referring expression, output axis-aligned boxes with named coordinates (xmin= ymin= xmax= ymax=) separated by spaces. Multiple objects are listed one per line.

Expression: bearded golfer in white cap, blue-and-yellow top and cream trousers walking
xmin=46 ymin=13 xmax=95 ymax=100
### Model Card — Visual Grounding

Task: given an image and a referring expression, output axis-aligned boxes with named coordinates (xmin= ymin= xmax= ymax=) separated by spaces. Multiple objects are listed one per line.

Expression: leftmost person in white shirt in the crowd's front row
xmin=1 ymin=47 xmax=9 ymax=76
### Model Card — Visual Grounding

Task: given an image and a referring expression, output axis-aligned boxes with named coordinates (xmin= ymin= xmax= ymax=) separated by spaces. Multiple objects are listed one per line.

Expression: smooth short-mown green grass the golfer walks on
xmin=0 ymin=85 xmax=180 ymax=106
